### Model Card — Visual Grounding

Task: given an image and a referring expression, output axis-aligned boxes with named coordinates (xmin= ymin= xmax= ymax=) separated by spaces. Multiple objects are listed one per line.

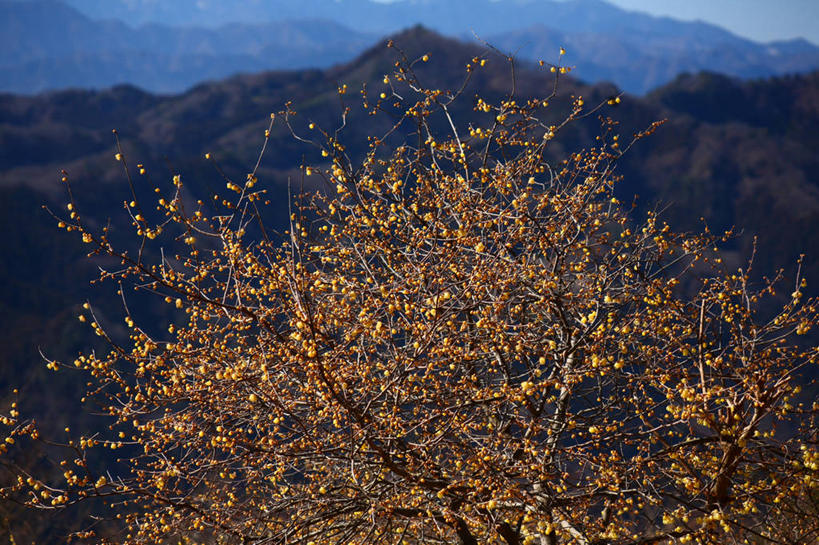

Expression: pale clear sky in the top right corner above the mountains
xmin=607 ymin=0 xmax=819 ymax=45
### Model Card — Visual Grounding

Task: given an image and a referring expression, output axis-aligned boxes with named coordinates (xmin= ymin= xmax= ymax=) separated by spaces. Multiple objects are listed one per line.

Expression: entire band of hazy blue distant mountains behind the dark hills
xmin=0 ymin=0 xmax=819 ymax=94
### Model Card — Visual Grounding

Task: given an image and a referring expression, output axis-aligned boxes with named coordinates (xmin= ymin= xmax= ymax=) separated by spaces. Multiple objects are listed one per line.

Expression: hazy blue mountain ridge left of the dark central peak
xmin=0 ymin=0 xmax=378 ymax=93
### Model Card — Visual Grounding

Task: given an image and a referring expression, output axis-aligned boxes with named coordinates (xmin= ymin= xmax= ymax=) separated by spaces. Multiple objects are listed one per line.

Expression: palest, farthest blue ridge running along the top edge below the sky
xmin=49 ymin=0 xmax=812 ymax=40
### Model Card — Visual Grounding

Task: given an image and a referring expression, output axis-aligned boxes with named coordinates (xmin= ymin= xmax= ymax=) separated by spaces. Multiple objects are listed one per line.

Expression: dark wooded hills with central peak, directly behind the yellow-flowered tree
xmin=0 ymin=23 xmax=819 ymax=541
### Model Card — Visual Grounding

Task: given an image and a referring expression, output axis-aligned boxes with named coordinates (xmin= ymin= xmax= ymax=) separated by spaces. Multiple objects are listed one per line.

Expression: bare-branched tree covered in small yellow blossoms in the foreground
xmin=3 ymin=46 xmax=819 ymax=545
